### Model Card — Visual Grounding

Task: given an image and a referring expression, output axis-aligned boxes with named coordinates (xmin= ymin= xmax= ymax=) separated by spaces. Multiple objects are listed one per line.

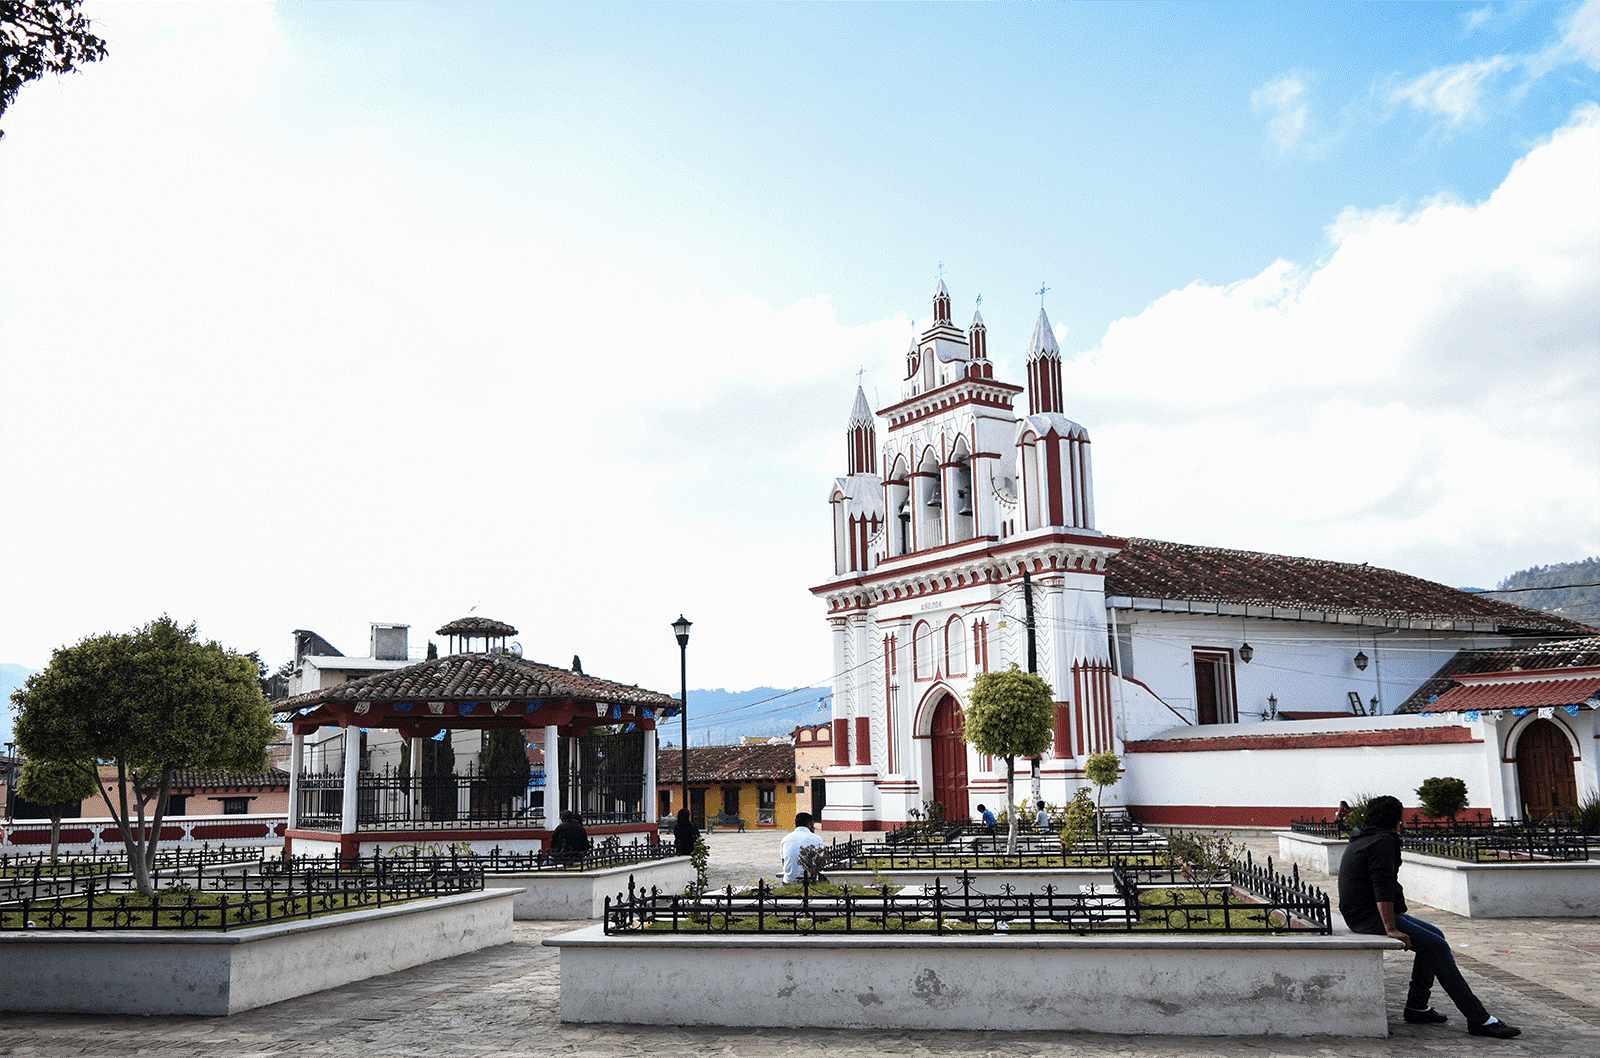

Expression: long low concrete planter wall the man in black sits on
xmin=544 ymin=925 xmax=1400 ymax=1037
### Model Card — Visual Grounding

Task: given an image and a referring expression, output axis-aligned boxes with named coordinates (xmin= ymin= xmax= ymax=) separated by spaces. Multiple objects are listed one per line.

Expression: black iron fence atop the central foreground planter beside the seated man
xmin=602 ymin=851 xmax=1331 ymax=935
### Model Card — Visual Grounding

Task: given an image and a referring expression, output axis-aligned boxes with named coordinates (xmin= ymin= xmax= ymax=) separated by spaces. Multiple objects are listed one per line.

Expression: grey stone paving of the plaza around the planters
xmin=0 ymin=832 xmax=1600 ymax=1058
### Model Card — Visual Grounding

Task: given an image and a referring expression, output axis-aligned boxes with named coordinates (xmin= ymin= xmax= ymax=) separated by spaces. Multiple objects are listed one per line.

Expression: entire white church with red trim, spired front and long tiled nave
xmin=811 ymin=280 xmax=1600 ymax=831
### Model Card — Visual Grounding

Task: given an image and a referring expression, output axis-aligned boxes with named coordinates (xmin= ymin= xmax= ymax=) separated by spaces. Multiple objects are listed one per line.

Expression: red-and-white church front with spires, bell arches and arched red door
xmin=811 ymin=282 xmax=1122 ymax=829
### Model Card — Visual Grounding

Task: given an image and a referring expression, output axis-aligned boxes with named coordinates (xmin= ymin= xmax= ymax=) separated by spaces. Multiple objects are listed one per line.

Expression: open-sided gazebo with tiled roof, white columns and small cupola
xmin=275 ymin=618 xmax=680 ymax=856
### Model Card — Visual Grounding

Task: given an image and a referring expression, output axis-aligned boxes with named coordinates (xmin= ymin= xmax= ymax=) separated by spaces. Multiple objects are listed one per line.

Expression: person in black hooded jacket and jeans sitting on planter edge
xmin=1339 ymin=796 xmax=1522 ymax=1040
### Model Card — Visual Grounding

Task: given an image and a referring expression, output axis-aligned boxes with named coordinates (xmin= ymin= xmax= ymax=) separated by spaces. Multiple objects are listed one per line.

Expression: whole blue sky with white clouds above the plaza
xmin=0 ymin=3 xmax=1600 ymax=733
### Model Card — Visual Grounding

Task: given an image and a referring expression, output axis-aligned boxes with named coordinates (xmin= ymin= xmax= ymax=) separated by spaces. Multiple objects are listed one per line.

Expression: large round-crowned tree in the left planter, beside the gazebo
xmin=11 ymin=616 xmax=277 ymax=896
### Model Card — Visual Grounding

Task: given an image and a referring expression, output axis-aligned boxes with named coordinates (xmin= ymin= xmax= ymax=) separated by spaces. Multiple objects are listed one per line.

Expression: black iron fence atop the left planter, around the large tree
xmin=0 ymin=860 xmax=483 ymax=932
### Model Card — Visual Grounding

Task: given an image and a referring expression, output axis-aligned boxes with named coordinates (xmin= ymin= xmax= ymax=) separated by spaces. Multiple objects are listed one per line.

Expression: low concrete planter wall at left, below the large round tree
xmin=0 ymin=888 xmax=514 ymax=1015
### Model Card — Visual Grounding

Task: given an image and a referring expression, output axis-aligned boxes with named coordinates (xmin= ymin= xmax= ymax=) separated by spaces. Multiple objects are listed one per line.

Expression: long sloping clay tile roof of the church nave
xmin=1106 ymin=536 xmax=1595 ymax=635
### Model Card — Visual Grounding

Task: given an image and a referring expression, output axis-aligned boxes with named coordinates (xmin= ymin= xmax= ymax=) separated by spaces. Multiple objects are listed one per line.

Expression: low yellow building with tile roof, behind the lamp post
xmin=656 ymin=741 xmax=797 ymax=831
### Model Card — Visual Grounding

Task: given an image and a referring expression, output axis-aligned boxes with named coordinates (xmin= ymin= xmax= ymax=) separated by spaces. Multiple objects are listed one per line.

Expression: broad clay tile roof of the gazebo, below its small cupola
xmin=272 ymin=653 xmax=678 ymax=712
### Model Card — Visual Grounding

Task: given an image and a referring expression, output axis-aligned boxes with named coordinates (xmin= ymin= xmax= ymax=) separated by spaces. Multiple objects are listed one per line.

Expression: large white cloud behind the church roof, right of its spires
xmin=1067 ymin=106 xmax=1600 ymax=583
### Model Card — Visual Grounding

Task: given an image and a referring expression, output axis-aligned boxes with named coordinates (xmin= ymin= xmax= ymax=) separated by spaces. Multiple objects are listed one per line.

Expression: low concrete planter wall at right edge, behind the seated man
xmin=1400 ymin=852 xmax=1600 ymax=919
